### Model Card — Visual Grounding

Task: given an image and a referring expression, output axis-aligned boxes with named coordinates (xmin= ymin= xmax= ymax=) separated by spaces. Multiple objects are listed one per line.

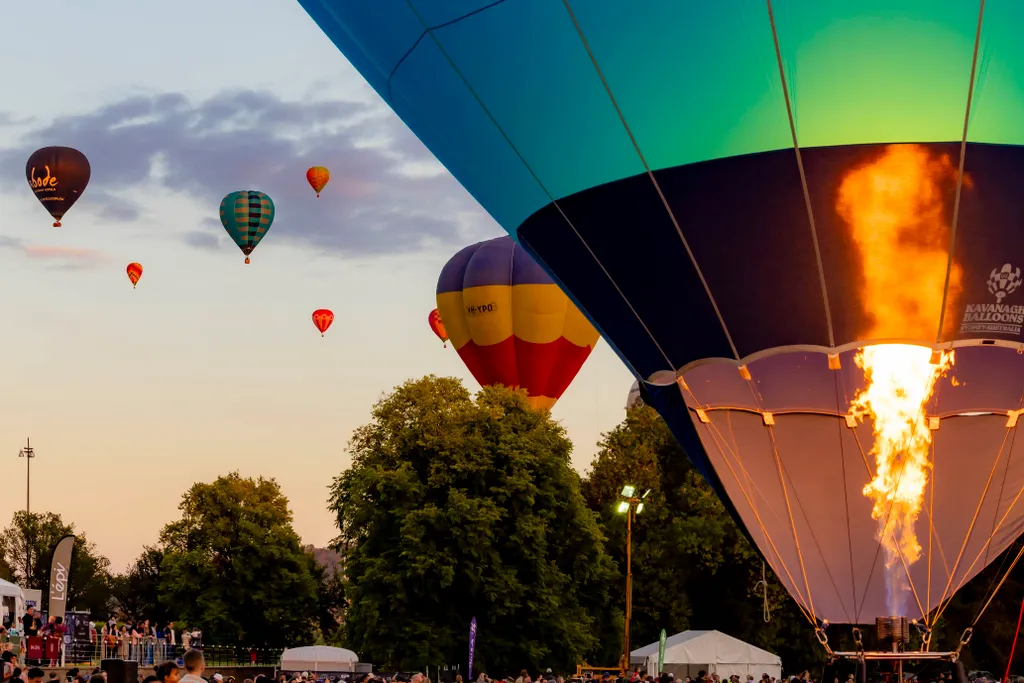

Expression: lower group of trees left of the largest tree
xmin=0 ymin=473 xmax=340 ymax=646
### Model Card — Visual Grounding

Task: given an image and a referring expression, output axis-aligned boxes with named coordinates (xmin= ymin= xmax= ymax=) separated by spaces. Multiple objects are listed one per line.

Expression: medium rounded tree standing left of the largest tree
xmin=159 ymin=472 xmax=319 ymax=646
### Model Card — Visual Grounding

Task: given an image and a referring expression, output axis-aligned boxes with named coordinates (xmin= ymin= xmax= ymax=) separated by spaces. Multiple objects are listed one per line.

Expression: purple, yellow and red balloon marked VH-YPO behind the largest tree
xmin=437 ymin=237 xmax=598 ymax=409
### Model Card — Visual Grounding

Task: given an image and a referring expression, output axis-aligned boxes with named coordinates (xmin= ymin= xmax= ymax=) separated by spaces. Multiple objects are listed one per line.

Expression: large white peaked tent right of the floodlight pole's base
xmin=630 ymin=631 xmax=782 ymax=681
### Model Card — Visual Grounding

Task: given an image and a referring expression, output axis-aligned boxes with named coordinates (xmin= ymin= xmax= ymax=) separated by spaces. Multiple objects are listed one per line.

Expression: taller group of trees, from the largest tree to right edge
xmin=331 ymin=376 xmax=1024 ymax=677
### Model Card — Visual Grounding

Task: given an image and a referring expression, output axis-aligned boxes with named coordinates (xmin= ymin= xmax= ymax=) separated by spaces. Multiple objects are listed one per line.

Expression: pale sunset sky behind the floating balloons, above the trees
xmin=0 ymin=0 xmax=633 ymax=571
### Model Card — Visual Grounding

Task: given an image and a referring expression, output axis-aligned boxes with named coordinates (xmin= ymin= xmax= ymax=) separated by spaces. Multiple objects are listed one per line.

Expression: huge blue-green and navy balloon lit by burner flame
xmin=299 ymin=0 xmax=1024 ymax=651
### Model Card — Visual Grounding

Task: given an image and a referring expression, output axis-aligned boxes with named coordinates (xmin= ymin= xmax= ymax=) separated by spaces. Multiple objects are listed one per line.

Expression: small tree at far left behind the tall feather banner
xmin=0 ymin=510 xmax=112 ymax=618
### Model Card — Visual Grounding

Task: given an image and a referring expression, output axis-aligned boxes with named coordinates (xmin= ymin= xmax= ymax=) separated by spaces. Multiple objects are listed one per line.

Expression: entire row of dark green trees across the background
xmin=9 ymin=376 xmax=1024 ymax=677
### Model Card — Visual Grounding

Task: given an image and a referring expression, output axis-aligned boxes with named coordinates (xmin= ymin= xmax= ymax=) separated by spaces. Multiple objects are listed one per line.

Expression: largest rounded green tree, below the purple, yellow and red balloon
xmin=331 ymin=376 xmax=613 ymax=675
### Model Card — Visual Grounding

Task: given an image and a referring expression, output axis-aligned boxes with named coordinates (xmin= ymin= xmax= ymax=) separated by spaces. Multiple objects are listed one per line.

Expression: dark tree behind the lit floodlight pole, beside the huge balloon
xmin=583 ymin=405 xmax=823 ymax=666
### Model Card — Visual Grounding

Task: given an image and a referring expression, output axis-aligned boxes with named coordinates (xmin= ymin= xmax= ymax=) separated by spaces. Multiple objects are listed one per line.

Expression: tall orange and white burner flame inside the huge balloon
xmin=836 ymin=144 xmax=970 ymax=616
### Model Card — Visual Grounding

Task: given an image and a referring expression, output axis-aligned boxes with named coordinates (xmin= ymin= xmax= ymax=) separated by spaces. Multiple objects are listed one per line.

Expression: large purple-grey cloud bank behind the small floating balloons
xmin=0 ymin=90 xmax=500 ymax=256
